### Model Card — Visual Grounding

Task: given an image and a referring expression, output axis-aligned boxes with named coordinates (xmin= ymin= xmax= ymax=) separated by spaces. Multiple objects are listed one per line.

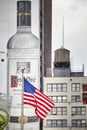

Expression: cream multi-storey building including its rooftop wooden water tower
xmin=43 ymin=47 xmax=87 ymax=130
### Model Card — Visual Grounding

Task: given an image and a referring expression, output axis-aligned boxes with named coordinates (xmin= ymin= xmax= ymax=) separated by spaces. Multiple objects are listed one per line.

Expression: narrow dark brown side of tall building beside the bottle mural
xmin=40 ymin=0 xmax=52 ymax=76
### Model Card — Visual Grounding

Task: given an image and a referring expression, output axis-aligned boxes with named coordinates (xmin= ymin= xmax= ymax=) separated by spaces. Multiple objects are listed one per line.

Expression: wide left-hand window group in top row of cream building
xmin=47 ymin=83 xmax=67 ymax=92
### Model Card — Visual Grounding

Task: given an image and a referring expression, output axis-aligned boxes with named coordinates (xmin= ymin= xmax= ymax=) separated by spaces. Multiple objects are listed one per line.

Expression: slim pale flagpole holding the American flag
xmin=21 ymin=68 xmax=24 ymax=130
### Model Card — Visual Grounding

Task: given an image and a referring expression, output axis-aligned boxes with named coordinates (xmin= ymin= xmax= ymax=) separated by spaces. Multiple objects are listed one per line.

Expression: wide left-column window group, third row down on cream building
xmin=50 ymin=107 xmax=67 ymax=115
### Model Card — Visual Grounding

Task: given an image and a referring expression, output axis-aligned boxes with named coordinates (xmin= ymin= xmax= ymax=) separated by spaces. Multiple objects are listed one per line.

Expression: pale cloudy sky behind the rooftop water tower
xmin=52 ymin=0 xmax=87 ymax=75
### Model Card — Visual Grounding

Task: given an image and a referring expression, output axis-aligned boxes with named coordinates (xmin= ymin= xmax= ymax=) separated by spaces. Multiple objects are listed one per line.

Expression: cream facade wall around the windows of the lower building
xmin=43 ymin=77 xmax=87 ymax=130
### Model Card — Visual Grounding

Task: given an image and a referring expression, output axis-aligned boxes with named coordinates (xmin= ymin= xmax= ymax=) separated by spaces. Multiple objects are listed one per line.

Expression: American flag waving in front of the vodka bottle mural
xmin=23 ymin=78 xmax=54 ymax=120
